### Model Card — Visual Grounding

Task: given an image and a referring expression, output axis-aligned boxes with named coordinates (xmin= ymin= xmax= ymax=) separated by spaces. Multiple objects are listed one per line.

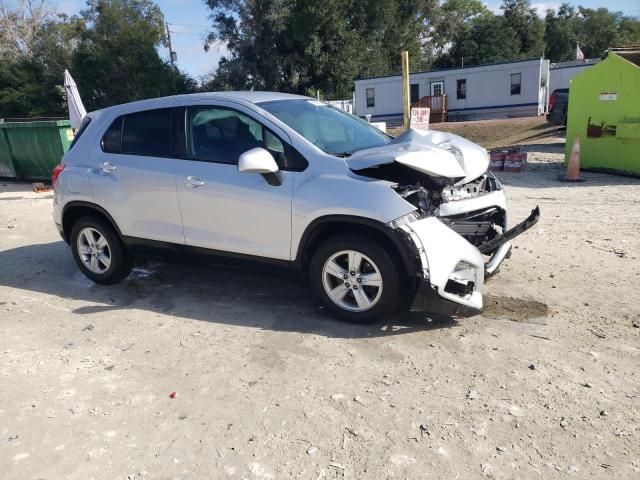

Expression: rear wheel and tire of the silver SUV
xmin=69 ymin=215 xmax=133 ymax=285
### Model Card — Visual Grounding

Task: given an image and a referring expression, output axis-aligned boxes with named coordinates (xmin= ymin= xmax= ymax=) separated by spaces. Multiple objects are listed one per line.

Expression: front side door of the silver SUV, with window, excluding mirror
xmin=177 ymin=106 xmax=295 ymax=260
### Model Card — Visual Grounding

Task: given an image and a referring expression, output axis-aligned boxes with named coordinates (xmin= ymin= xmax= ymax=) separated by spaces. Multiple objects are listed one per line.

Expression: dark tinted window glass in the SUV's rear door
xmin=121 ymin=108 xmax=173 ymax=157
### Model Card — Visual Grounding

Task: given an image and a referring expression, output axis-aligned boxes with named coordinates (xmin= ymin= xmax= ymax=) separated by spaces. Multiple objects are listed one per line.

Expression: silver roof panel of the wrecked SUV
xmin=92 ymin=91 xmax=310 ymax=117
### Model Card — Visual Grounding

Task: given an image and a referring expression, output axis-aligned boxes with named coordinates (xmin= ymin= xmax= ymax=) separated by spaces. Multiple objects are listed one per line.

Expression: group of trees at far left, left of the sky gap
xmin=0 ymin=0 xmax=197 ymax=117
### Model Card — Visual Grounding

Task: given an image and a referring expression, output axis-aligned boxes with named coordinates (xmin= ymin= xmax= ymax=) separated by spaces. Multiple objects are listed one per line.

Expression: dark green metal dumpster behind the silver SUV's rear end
xmin=0 ymin=120 xmax=73 ymax=180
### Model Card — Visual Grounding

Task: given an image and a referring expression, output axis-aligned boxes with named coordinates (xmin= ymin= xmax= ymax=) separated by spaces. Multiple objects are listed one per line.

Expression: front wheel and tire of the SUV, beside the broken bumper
xmin=309 ymin=236 xmax=401 ymax=323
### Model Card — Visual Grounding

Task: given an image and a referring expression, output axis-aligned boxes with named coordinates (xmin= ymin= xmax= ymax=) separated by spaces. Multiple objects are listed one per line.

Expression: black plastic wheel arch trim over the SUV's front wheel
xmin=294 ymin=215 xmax=419 ymax=279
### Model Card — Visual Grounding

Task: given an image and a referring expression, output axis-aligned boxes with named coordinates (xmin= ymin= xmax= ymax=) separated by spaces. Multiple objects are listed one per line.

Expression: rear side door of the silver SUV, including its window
xmin=89 ymin=108 xmax=184 ymax=244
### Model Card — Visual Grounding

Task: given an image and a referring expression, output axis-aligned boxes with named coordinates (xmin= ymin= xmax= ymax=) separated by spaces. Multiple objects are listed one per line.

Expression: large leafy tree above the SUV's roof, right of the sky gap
xmin=206 ymin=0 xmax=436 ymax=98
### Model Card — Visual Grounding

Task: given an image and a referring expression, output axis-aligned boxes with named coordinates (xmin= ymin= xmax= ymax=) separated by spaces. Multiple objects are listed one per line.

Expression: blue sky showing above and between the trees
xmin=50 ymin=0 xmax=640 ymax=80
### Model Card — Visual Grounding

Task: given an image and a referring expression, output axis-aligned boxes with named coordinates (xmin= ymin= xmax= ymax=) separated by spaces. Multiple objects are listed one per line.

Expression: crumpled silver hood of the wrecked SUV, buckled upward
xmin=345 ymin=128 xmax=489 ymax=185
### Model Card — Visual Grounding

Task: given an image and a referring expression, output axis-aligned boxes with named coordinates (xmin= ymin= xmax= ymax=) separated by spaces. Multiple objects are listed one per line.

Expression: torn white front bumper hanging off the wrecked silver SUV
xmin=399 ymin=207 xmax=540 ymax=310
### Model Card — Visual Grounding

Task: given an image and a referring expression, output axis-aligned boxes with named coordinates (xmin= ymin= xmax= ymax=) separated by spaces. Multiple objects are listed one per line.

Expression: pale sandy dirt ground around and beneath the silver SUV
xmin=0 ymin=137 xmax=640 ymax=480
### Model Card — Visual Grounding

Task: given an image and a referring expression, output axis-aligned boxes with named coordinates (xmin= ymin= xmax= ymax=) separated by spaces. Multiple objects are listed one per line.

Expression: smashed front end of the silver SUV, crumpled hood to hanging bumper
xmin=348 ymin=130 xmax=540 ymax=309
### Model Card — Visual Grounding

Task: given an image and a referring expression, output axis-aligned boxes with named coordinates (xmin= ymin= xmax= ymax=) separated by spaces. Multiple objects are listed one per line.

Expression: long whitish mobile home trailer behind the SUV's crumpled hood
xmin=355 ymin=59 xmax=549 ymax=122
